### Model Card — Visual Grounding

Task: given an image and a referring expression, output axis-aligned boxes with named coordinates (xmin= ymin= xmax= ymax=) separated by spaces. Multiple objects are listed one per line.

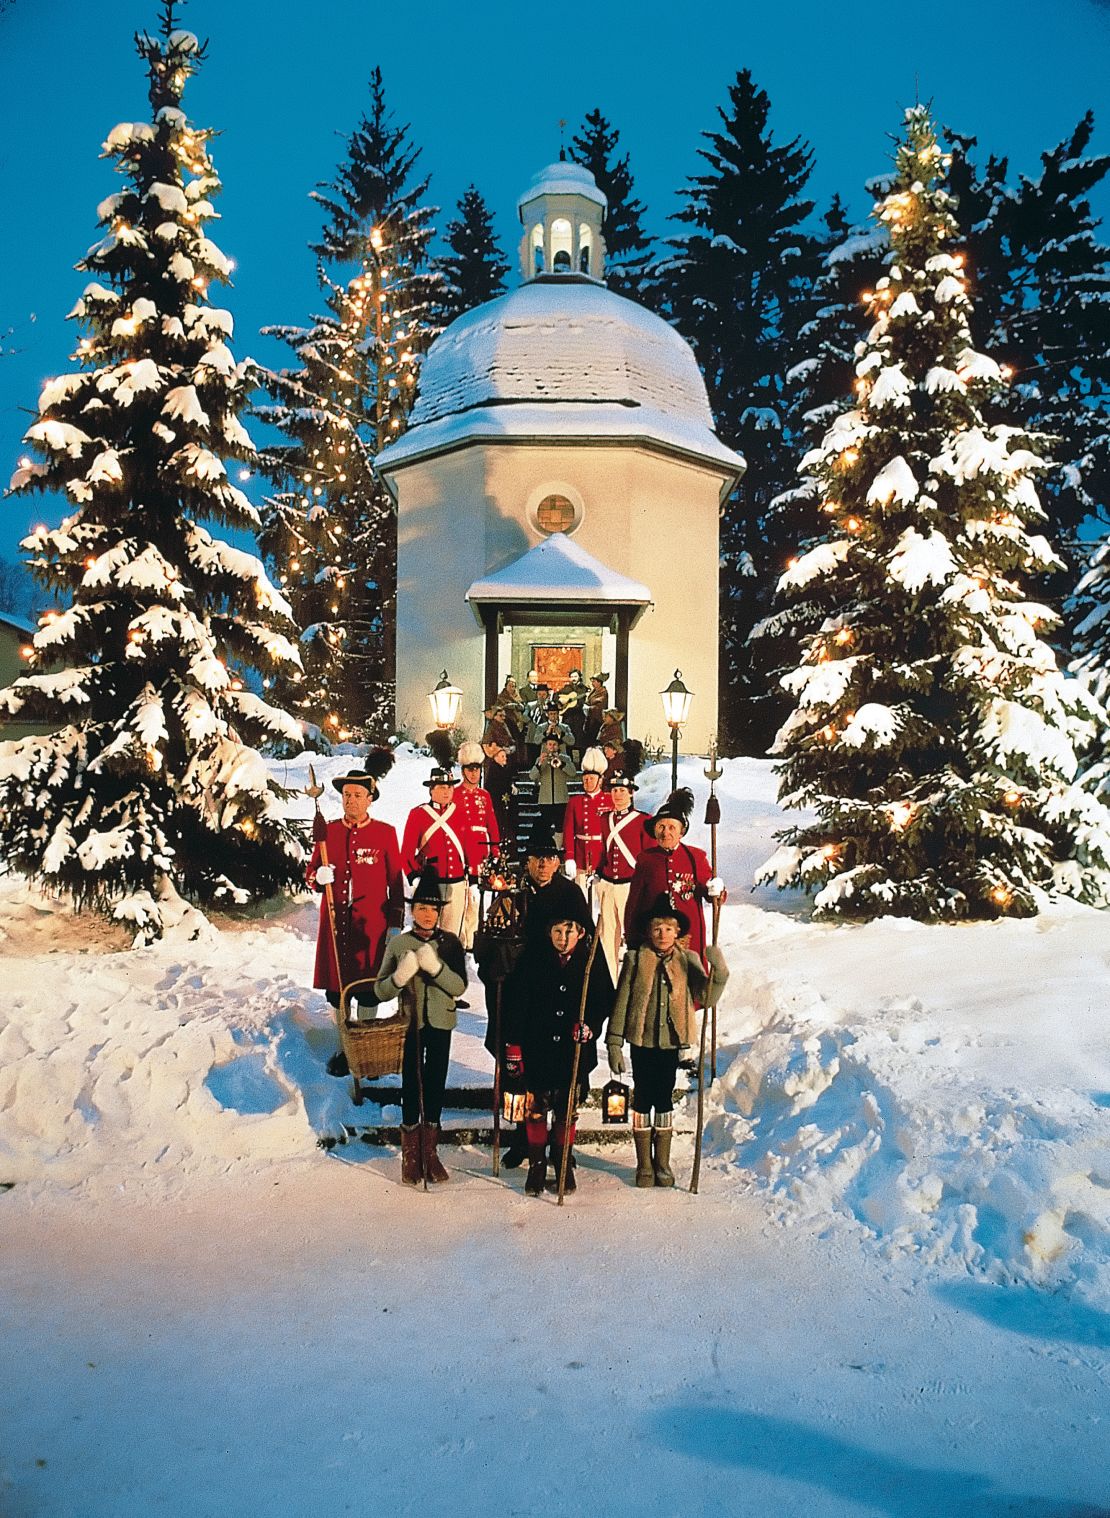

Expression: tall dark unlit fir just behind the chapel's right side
xmin=654 ymin=70 xmax=820 ymax=753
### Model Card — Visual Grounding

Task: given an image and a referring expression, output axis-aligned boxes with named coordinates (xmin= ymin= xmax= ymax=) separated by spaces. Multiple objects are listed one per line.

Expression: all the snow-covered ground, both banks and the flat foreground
xmin=0 ymin=754 xmax=1110 ymax=1518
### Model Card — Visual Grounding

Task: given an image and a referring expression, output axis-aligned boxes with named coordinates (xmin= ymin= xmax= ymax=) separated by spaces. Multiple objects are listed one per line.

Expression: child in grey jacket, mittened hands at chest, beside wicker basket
xmin=374 ymin=865 xmax=466 ymax=1186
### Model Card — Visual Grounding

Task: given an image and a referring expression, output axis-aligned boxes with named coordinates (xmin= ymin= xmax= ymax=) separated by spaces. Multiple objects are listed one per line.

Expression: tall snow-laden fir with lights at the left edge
xmin=0 ymin=0 xmax=302 ymax=937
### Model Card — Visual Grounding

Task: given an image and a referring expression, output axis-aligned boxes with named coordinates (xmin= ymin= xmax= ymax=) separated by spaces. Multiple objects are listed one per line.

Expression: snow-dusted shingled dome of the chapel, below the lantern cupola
xmin=410 ymin=276 xmax=714 ymax=433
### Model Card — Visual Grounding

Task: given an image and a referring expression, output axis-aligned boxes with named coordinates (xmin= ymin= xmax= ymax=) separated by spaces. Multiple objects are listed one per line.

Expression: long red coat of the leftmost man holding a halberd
xmin=308 ymin=817 xmax=404 ymax=991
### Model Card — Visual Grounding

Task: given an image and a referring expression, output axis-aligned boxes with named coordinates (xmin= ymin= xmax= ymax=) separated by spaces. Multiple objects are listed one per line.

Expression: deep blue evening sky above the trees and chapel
xmin=0 ymin=0 xmax=1110 ymax=570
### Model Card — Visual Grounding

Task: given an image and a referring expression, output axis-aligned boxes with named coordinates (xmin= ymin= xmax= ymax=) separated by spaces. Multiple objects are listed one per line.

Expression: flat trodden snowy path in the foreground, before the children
xmin=0 ymin=1149 xmax=1110 ymax=1518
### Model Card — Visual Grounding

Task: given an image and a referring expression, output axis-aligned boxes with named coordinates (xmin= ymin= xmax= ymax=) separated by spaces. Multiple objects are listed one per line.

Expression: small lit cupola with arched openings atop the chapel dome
xmin=516 ymin=161 xmax=607 ymax=284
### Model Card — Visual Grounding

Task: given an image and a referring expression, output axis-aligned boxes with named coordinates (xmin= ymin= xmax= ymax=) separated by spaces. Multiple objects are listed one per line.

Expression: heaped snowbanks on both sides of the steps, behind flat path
xmin=0 ymin=745 xmax=1110 ymax=1302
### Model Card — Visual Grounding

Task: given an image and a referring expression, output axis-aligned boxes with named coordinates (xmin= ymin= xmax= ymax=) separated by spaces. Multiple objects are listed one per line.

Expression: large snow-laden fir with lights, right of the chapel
xmin=764 ymin=106 xmax=1110 ymax=918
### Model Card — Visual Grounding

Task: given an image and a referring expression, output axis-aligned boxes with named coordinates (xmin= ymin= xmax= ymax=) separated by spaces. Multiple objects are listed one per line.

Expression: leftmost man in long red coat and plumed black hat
xmin=307 ymin=748 xmax=404 ymax=1075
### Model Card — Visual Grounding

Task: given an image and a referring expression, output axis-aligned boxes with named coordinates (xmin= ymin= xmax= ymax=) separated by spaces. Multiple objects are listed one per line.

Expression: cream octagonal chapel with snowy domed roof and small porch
xmin=378 ymin=162 xmax=744 ymax=751
